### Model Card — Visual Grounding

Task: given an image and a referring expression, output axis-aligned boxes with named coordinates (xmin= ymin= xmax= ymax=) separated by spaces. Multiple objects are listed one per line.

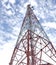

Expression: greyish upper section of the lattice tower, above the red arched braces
xmin=19 ymin=4 xmax=49 ymax=40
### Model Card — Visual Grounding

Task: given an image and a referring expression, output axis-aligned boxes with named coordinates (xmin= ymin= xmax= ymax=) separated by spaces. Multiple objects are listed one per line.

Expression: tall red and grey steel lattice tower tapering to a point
xmin=9 ymin=5 xmax=56 ymax=65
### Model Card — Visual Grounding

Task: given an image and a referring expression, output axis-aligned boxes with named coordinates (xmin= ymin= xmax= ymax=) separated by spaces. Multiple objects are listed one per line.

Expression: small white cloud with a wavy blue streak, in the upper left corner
xmin=2 ymin=2 xmax=15 ymax=16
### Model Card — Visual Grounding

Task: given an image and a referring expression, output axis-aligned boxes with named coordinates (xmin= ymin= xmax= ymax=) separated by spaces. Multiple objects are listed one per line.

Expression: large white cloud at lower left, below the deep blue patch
xmin=0 ymin=27 xmax=17 ymax=65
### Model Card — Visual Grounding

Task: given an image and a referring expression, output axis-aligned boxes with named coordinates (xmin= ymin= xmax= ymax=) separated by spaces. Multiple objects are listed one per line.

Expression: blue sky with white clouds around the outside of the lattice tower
xmin=0 ymin=0 xmax=56 ymax=65
